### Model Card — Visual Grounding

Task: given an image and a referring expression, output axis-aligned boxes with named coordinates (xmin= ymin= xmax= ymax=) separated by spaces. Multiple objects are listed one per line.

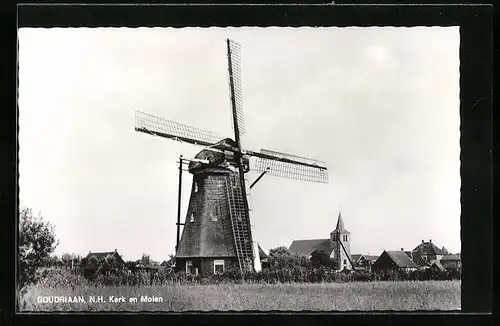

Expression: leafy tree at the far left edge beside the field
xmin=18 ymin=208 xmax=59 ymax=290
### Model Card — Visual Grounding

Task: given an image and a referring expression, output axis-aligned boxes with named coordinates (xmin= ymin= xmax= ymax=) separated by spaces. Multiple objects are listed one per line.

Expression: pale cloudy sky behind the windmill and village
xmin=18 ymin=27 xmax=461 ymax=261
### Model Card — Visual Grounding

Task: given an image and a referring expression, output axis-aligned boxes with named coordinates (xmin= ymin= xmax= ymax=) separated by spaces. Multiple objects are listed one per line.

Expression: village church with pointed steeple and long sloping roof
xmin=289 ymin=213 xmax=352 ymax=270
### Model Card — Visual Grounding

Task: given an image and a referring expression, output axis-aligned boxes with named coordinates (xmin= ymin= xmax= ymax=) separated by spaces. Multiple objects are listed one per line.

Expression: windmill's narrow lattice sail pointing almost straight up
xmin=227 ymin=39 xmax=245 ymax=138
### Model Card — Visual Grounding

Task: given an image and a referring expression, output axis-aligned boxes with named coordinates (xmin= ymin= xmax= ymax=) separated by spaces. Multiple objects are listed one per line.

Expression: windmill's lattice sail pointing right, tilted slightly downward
xmin=247 ymin=149 xmax=328 ymax=183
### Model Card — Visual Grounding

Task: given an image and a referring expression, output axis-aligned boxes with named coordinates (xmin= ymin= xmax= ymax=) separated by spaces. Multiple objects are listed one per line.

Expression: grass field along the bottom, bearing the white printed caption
xmin=22 ymin=281 xmax=460 ymax=311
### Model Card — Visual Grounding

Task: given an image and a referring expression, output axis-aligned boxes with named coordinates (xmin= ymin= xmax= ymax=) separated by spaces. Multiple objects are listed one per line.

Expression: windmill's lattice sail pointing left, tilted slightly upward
xmin=135 ymin=111 xmax=222 ymax=146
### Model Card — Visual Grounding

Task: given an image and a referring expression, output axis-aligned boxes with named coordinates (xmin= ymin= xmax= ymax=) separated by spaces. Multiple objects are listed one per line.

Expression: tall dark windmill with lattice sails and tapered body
xmin=135 ymin=39 xmax=328 ymax=274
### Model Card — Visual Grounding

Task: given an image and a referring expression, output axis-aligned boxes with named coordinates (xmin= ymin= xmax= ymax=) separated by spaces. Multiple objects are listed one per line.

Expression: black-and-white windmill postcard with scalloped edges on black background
xmin=17 ymin=26 xmax=462 ymax=312
